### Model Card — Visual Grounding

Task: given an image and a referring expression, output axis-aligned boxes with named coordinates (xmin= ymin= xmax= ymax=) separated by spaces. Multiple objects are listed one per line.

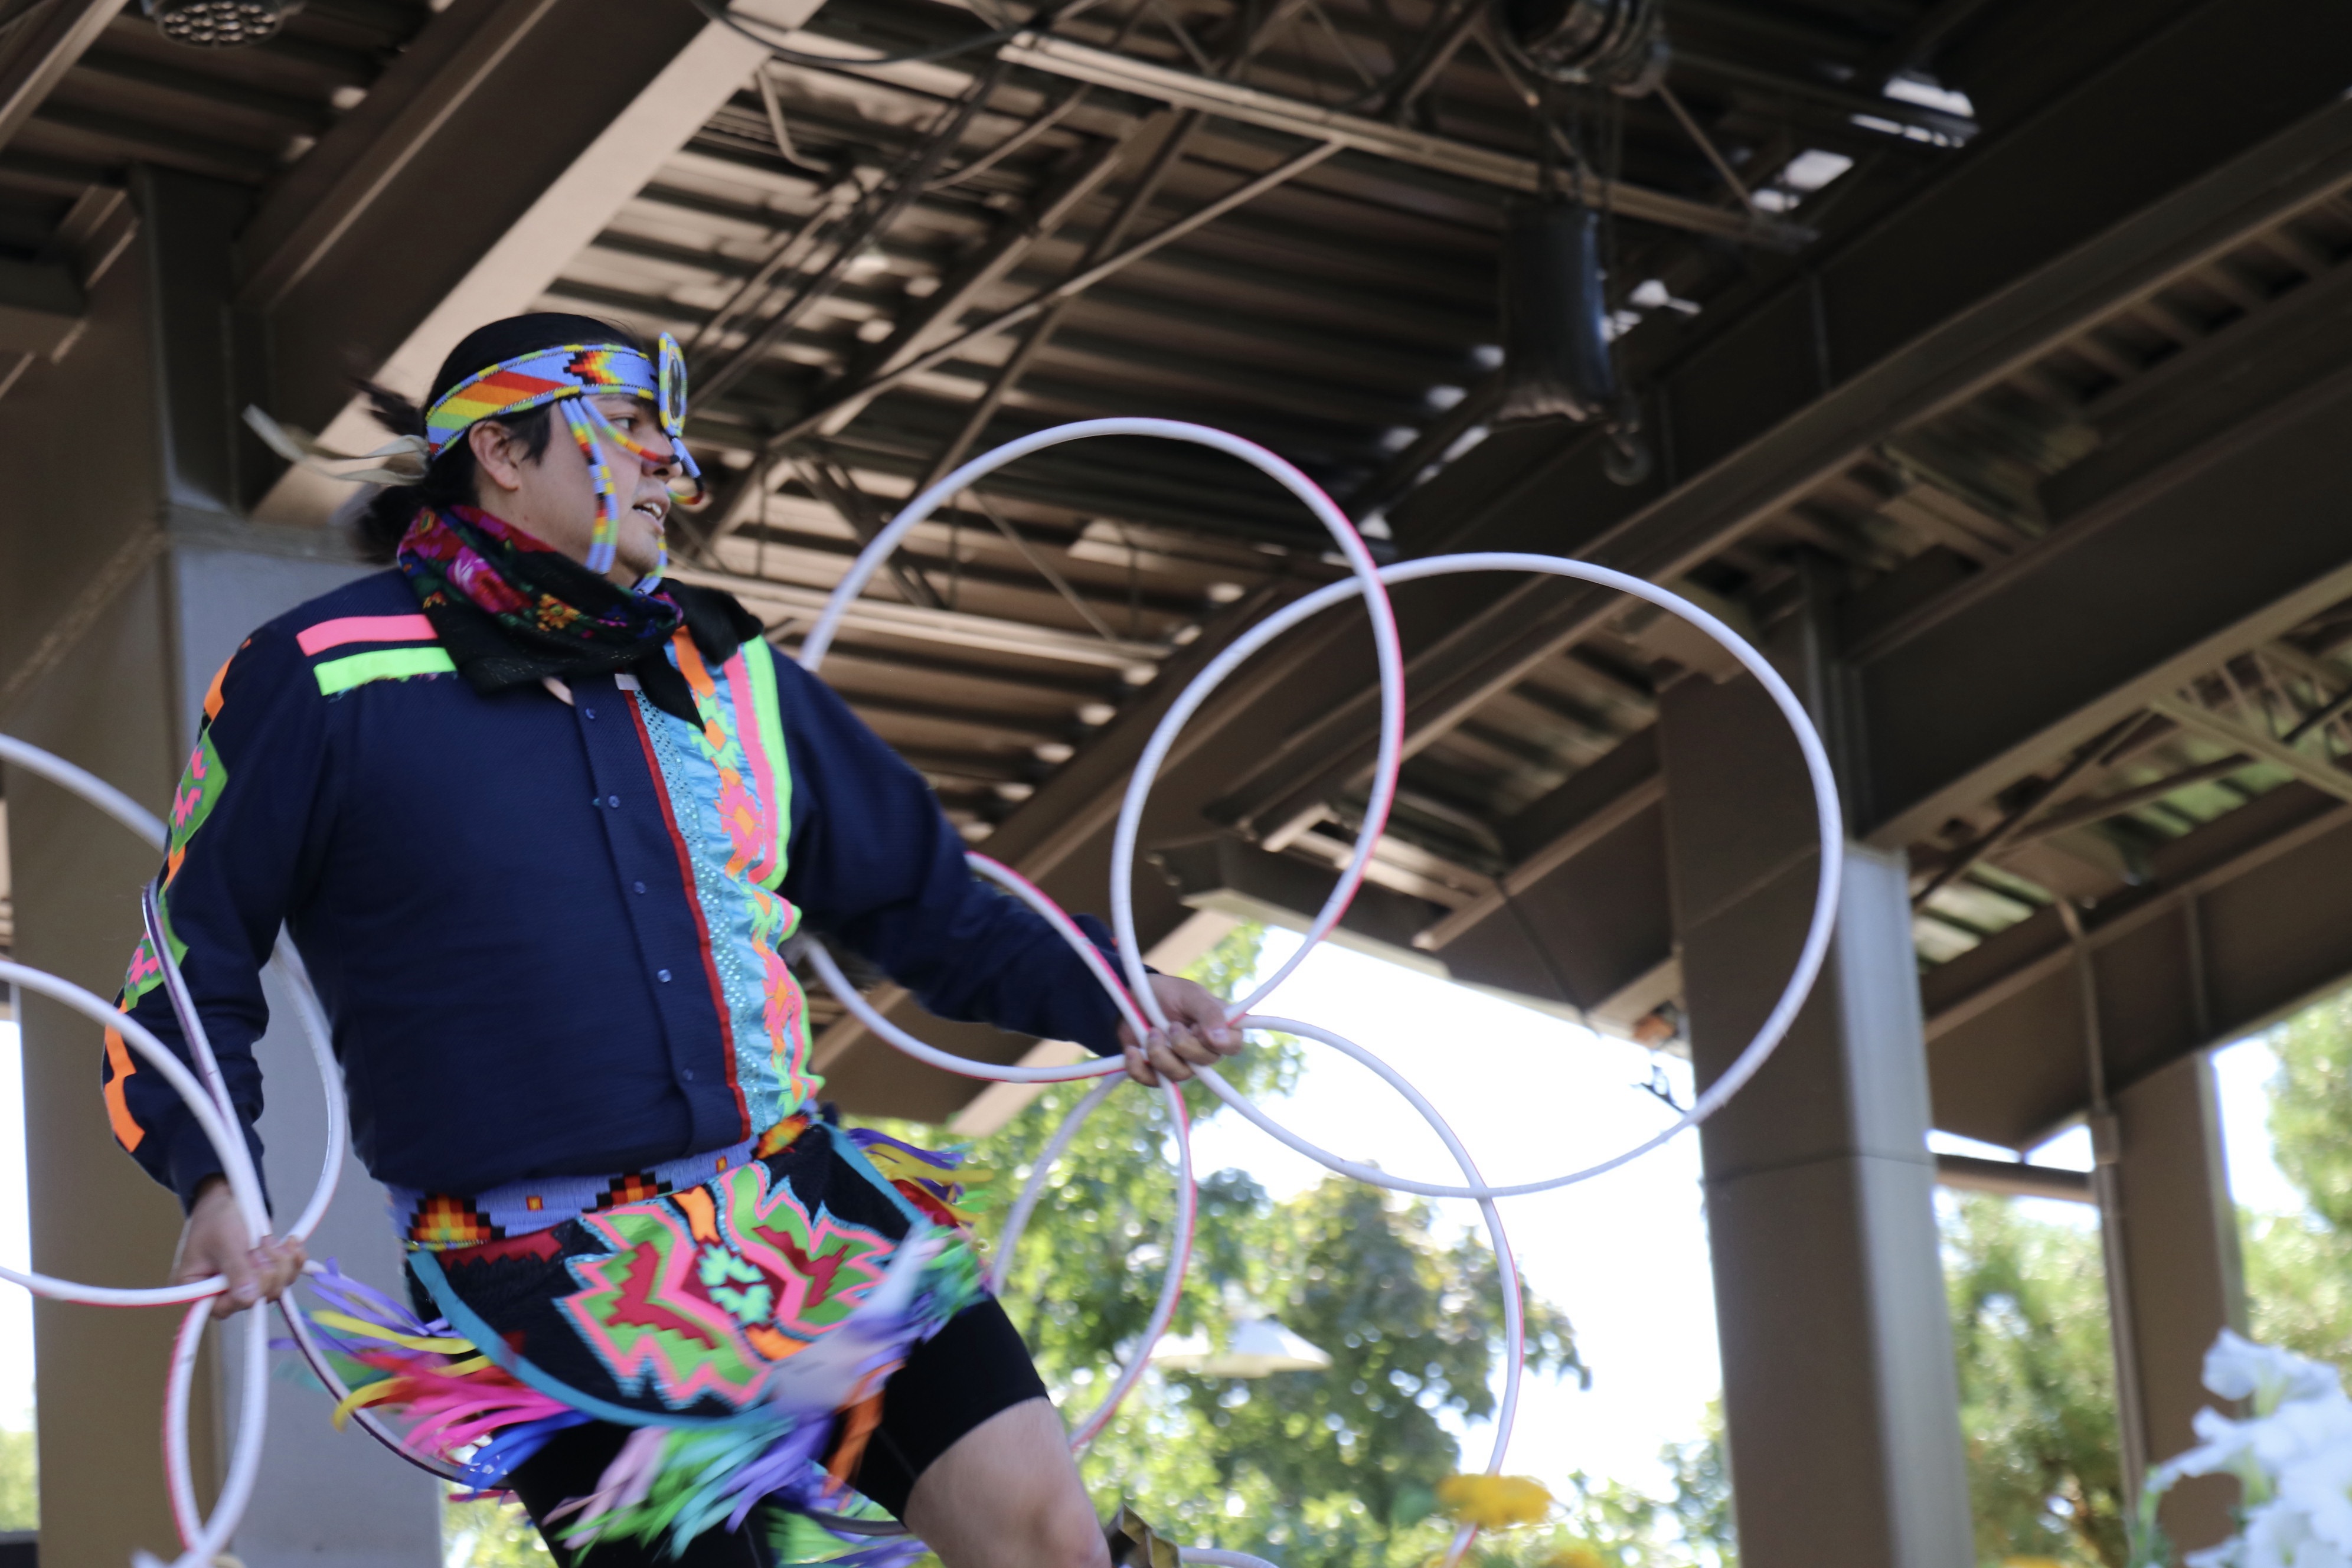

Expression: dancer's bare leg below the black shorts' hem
xmin=906 ymin=1399 xmax=1110 ymax=1568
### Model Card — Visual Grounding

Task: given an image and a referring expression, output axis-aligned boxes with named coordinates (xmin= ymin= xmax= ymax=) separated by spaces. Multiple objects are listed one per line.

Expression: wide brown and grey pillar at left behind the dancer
xmin=0 ymin=174 xmax=440 ymax=1568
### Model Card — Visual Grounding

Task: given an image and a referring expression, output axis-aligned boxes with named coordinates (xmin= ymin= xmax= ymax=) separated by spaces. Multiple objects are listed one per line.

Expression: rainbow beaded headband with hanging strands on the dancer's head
xmin=426 ymin=331 xmax=703 ymax=588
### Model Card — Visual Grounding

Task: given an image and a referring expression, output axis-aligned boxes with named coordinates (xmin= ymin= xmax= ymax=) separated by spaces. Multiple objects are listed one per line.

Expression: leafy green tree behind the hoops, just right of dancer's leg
xmin=931 ymin=929 xmax=1583 ymax=1568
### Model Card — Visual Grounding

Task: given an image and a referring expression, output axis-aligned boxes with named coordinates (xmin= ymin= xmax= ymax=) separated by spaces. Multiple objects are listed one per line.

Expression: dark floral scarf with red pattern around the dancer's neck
xmin=395 ymin=505 xmax=762 ymax=724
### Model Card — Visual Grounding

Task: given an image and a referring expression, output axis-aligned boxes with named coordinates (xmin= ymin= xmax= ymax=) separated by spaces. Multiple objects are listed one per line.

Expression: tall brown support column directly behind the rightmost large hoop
xmin=1658 ymin=644 xmax=1976 ymax=1568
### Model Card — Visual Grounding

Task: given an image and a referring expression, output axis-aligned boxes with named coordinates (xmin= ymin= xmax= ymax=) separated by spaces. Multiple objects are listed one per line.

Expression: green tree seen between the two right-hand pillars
xmin=1943 ymin=1192 xmax=2126 ymax=1568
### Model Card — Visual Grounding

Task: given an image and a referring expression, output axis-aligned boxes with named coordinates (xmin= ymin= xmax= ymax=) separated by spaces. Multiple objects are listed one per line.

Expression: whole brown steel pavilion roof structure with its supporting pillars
xmin=0 ymin=0 xmax=2352 ymax=1568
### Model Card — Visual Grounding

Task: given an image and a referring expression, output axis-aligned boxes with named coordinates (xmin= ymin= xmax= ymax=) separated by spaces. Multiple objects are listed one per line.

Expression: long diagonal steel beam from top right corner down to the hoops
xmin=1194 ymin=21 xmax=2352 ymax=835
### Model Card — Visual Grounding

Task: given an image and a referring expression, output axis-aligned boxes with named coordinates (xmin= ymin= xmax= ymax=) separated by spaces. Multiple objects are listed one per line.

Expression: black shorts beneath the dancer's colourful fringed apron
xmin=508 ymin=1300 xmax=1044 ymax=1568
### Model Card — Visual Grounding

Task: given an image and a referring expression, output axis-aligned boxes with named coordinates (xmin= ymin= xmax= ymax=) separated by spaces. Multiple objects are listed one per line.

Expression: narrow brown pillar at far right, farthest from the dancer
xmin=2108 ymin=1051 xmax=2246 ymax=1551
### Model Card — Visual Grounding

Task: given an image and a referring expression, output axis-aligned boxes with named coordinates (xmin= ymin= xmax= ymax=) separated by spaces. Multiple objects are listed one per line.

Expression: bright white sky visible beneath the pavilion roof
xmin=0 ymin=949 xmax=2300 ymax=1488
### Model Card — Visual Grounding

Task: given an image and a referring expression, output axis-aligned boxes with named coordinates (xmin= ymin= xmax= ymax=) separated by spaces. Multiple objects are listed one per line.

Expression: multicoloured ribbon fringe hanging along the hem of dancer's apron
xmin=306 ymin=1175 xmax=983 ymax=1568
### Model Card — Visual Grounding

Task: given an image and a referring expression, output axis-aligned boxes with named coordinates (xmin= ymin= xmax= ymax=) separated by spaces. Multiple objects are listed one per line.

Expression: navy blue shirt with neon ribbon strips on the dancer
xmin=103 ymin=571 xmax=1117 ymax=1201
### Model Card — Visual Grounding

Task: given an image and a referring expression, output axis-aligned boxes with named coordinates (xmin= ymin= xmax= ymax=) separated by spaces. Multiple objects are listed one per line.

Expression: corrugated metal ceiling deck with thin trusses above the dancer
xmin=501 ymin=0 xmax=2004 ymax=1100
